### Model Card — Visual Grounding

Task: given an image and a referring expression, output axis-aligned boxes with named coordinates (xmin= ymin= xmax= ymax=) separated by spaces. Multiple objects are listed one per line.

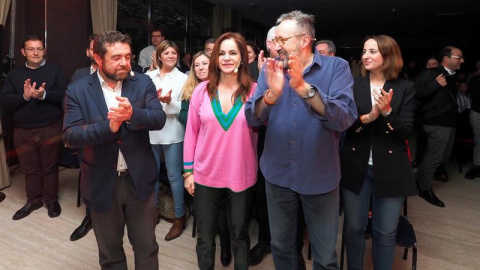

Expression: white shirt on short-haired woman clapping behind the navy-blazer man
xmin=145 ymin=68 xmax=188 ymax=144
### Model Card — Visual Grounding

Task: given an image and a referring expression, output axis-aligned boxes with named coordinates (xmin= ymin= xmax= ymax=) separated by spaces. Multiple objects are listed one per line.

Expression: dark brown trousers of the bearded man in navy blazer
xmin=91 ymin=176 xmax=158 ymax=270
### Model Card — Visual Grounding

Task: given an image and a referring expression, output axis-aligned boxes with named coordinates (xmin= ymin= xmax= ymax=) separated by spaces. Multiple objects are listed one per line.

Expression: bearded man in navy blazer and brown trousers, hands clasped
xmin=62 ymin=31 xmax=166 ymax=269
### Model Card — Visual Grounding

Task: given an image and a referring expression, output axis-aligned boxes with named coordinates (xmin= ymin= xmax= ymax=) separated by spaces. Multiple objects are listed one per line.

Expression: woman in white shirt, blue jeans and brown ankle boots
xmin=146 ymin=40 xmax=187 ymax=241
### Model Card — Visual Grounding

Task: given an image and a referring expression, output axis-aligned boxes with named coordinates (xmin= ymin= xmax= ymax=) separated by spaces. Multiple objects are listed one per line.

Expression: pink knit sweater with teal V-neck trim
xmin=183 ymin=82 xmax=258 ymax=192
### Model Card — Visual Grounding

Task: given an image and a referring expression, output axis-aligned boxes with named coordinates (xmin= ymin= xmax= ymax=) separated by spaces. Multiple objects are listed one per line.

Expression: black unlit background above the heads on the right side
xmin=206 ymin=0 xmax=480 ymax=62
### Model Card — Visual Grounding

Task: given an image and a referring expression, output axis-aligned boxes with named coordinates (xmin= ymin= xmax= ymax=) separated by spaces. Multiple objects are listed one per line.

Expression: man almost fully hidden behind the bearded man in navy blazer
xmin=70 ymin=34 xmax=98 ymax=241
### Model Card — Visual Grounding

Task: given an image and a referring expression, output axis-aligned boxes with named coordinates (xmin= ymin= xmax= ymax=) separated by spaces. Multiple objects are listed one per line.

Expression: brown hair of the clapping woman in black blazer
xmin=362 ymin=35 xmax=403 ymax=80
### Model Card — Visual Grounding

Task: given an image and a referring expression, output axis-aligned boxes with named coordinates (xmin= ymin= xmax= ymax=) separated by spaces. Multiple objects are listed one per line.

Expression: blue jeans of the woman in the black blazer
xmin=342 ymin=166 xmax=405 ymax=270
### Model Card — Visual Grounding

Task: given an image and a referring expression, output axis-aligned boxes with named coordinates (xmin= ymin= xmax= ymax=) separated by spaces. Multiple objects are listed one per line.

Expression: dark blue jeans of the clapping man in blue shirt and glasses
xmin=266 ymin=181 xmax=339 ymax=270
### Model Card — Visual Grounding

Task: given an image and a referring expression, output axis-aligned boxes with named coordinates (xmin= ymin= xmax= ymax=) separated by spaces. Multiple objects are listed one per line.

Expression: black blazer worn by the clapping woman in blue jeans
xmin=340 ymin=76 xmax=417 ymax=197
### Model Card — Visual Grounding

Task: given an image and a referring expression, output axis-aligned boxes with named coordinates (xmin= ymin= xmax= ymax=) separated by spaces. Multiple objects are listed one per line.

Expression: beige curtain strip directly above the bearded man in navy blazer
xmin=90 ymin=0 xmax=118 ymax=34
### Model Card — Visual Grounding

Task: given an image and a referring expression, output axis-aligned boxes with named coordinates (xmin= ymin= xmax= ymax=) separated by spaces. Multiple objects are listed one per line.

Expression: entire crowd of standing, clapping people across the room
xmin=0 ymin=7 xmax=480 ymax=270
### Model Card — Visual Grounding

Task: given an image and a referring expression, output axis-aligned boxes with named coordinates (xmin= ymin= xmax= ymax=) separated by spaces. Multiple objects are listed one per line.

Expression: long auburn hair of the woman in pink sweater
xmin=207 ymin=32 xmax=253 ymax=102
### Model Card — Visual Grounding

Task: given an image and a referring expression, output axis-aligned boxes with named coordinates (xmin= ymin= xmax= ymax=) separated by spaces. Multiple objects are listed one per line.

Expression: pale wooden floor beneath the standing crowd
xmin=0 ymin=161 xmax=480 ymax=270
